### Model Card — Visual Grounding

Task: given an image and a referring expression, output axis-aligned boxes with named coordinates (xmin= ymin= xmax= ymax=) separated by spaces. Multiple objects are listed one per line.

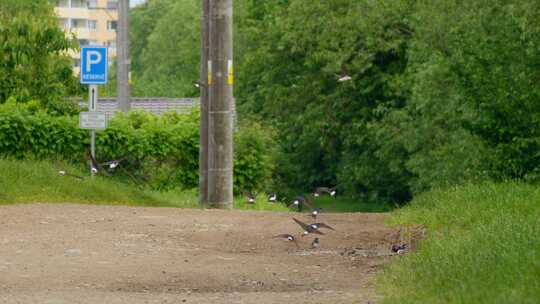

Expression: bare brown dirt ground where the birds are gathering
xmin=0 ymin=204 xmax=391 ymax=304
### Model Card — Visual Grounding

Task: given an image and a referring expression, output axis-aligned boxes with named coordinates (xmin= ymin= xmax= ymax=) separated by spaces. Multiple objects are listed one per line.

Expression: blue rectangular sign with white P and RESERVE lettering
xmin=81 ymin=46 xmax=108 ymax=84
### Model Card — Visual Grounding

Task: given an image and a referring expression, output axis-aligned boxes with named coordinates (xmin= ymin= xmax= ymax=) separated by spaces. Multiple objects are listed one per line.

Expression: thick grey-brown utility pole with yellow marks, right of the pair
xmin=208 ymin=0 xmax=234 ymax=208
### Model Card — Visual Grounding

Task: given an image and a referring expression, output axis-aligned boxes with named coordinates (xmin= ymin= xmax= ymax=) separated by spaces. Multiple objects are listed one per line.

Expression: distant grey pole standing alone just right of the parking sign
xmin=116 ymin=0 xmax=131 ymax=113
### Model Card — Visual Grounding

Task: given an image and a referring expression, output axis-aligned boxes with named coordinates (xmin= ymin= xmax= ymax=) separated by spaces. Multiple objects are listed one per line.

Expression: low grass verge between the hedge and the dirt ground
xmin=0 ymin=158 xmax=390 ymax=212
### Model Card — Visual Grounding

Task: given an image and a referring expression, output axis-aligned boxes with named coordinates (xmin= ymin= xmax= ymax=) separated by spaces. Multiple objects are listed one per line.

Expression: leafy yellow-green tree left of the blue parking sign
xmin=0 ymin=0 xmax=79 ymax=113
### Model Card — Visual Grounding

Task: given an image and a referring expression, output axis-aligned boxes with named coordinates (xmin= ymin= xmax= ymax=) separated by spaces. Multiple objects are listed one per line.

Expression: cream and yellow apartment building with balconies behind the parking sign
xmin=55 ymin=0 xmax=118 ymax=73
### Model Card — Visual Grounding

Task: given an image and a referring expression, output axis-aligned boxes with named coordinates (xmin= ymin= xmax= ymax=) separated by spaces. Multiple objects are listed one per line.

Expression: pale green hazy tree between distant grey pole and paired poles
xmin=131 ymin=0 xmax=200 ymax=97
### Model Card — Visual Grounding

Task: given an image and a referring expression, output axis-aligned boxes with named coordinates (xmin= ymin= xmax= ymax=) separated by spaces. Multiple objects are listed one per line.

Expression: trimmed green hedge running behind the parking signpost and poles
xmin=0 ymin=102 xmax=275 ymax=193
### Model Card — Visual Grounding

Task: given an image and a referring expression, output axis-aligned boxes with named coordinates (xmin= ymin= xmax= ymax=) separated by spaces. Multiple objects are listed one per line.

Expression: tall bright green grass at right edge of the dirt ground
xmin=379 ymin=182 xmax=540 ymax=304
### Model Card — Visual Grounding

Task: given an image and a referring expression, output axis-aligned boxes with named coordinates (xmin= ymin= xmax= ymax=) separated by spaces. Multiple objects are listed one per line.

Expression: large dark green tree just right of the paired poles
xmin=236 ymin=0 xmax=410 ymax=200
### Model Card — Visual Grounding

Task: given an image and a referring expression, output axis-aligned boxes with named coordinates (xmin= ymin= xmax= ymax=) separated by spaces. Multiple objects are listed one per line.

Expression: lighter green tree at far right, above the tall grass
xmin=395 ymin=0 xmax=540 ymax=191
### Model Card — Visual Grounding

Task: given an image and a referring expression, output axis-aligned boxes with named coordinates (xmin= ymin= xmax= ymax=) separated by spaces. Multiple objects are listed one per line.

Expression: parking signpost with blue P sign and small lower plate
xmin=79 ymin=46 xmax=109 ymax=176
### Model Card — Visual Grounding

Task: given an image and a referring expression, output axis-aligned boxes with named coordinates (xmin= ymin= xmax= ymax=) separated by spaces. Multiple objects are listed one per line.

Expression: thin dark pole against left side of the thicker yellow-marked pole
xmin=199 ymin=0 xmax=210 ymax=206
